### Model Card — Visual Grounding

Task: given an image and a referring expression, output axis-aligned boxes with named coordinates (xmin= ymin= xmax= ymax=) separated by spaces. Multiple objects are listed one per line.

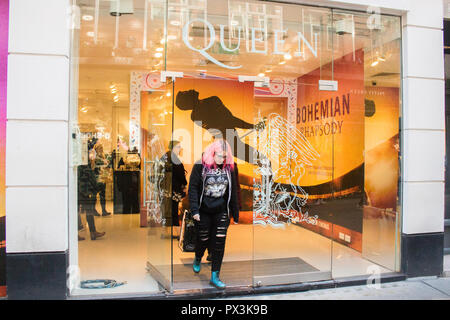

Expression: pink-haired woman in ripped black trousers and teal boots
xmin=188 ymin=139 xmax=239 ymax=289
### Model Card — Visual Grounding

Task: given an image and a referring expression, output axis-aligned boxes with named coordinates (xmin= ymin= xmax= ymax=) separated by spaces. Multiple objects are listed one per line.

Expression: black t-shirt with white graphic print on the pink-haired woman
xmin=201 ymin=168 xmax=228 ymax=213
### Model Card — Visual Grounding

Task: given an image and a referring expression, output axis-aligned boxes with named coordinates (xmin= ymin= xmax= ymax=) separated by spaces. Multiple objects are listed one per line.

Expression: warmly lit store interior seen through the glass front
xmin=71 ymin=0 xmax=401 ymax=295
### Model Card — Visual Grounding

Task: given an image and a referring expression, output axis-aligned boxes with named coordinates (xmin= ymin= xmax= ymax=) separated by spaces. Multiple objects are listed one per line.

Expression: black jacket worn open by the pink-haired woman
xmin=188 ymin=162 xmax=239 ymax=223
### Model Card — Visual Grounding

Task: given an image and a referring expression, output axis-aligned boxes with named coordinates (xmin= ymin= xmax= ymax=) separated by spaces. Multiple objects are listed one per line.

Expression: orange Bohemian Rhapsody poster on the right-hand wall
xmin=296 ymin=50 xmax=365 ymax=251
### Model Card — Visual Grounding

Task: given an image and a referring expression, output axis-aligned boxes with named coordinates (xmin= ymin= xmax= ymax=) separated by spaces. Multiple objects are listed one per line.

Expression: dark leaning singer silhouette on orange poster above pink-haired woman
xmin=175 ymin=90 xmax=264 ymax=164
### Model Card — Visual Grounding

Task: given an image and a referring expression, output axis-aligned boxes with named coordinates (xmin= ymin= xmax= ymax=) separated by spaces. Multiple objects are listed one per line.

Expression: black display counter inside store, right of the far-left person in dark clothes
xmin=113 ymin=170 xmax=141 ymax=214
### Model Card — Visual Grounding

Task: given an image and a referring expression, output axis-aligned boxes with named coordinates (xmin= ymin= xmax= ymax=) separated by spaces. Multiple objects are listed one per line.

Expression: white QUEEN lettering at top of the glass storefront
xmin=182 ymin=19 xmax=318 ymax=69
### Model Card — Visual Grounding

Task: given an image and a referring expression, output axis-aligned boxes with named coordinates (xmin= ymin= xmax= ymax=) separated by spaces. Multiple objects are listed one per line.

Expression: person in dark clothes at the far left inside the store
xmin=78 ymin=140 xmax=105 ymax=240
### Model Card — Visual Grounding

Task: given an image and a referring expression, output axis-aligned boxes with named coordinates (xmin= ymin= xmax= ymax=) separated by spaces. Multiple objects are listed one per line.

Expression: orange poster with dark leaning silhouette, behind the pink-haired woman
xmin=141 ymin=77 xmax=255 ymax=225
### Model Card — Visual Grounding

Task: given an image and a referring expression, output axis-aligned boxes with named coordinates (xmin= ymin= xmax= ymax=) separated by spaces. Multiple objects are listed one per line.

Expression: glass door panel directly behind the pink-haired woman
xmin=173 ymin=76 xmax=254 ymax=290
